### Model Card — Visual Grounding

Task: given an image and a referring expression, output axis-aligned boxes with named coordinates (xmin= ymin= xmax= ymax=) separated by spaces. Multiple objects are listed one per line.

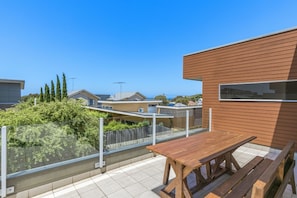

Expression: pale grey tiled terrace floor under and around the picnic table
xmin=28 ymin=145 xmax=297 ymax=198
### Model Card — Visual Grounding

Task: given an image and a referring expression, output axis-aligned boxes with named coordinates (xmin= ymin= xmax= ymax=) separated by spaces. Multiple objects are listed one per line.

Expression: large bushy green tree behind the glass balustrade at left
xmin=0 ymin=100 xmax=107 ymax=172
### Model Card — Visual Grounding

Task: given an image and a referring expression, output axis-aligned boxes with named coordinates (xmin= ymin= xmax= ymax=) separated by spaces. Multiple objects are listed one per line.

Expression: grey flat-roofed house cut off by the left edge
xmin=0 ymin=79 xmax=25 ymax=109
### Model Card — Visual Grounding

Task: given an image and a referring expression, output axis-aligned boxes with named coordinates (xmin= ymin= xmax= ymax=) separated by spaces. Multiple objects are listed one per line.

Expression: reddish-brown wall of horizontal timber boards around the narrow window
xmin=183 ymin=29 xmax=297 ymax=148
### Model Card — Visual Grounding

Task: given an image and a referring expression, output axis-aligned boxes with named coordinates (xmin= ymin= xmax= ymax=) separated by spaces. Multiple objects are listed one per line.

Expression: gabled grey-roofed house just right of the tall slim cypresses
xmin=68 ymin=89 xmax=100 ymax=107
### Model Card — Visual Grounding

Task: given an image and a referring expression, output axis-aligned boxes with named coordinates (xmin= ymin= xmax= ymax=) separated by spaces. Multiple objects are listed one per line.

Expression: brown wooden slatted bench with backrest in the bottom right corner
xmin=206 ymin=142 xmax=296 ymax=198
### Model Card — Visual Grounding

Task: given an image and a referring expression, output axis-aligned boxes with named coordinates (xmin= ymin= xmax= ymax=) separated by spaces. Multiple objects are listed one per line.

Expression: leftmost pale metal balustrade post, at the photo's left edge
xmin=1 ymin=126 xmax=7 ymax=197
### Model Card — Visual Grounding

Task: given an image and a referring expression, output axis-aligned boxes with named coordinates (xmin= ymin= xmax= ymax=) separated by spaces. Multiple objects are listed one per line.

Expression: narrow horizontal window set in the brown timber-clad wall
xmin=219 ymin=80 xmax=297 ymax=102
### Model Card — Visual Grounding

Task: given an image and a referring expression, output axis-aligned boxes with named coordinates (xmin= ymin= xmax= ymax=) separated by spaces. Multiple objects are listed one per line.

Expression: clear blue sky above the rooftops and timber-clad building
xmin=0 ymin=0 xmax=297 ymax=97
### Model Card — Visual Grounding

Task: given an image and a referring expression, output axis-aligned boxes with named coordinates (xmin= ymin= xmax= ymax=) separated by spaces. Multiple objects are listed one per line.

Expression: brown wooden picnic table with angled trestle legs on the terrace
xmin=147 ymin=132 xmax=256 ymax=198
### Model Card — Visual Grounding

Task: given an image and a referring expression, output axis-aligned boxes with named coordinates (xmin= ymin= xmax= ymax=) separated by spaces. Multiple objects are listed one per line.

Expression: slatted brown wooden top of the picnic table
xmin=146 ymin=132 xmax=256 ymax=169
